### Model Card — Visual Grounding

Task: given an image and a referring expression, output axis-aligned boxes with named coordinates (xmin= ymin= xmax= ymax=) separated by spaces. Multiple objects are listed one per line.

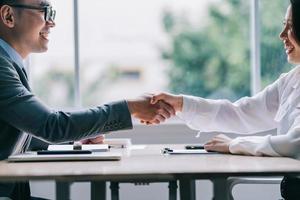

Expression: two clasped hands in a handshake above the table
xmin=127 ymin=93 xmax=183 ymax=124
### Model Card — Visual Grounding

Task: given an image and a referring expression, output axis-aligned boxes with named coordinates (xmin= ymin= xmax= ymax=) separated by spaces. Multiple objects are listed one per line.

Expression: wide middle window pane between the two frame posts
xmin=79 ymin=0 xmax=250 ymax=106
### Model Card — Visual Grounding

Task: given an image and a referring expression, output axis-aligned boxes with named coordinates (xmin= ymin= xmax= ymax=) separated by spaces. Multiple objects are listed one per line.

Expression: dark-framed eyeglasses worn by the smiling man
xmin=7 ymin=4 xmax=56 ymax=22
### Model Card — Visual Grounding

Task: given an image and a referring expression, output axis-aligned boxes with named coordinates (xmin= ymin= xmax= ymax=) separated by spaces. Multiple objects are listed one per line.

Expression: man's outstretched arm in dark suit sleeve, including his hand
xmin=0 ymin=58 xmax=173 ymax=142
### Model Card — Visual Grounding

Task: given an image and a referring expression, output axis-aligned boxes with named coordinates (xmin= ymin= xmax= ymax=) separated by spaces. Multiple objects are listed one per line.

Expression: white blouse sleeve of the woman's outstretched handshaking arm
xmin=177 ymin=74 xmax=284 ymax=134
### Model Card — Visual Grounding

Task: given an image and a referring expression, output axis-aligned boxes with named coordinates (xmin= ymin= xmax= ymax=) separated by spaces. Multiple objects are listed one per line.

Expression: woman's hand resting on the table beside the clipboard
xmin=204 ymin=134 xmax=232 ymax=153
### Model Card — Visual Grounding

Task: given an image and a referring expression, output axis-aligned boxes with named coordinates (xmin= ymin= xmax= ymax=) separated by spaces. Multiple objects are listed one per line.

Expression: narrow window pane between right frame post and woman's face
xmin=260 ymin=0 xmax=291 ymax=87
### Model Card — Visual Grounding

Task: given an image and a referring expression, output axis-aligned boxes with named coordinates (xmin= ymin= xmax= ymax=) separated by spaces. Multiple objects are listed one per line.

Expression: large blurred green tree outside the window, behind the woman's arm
xmin=162 ymin=0 xmax=287 ymax=100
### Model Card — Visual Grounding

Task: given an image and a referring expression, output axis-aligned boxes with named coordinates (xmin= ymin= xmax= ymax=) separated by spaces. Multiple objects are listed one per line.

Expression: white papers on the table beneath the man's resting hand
xmin=48 ymin=144 xmax=108 ymax=152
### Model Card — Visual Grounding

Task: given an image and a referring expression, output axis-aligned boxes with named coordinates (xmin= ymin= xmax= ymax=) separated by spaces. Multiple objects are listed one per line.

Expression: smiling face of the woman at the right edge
xmin=279 ymin=6 xmax=300 ymax=64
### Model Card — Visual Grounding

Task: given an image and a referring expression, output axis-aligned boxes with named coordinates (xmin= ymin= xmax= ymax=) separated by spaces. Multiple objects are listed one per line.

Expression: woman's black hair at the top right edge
xmin=290 ymin=0 xmax=300 ymax=43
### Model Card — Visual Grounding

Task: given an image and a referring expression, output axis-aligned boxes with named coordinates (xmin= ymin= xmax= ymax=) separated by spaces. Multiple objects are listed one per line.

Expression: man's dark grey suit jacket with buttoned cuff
xmin=0 ymin=48 xmax=132 ymax=197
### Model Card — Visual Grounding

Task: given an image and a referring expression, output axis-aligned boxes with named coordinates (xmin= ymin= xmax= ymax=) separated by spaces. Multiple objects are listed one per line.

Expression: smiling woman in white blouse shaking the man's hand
xmin=152 ymin=0 xmax=300 ymax=199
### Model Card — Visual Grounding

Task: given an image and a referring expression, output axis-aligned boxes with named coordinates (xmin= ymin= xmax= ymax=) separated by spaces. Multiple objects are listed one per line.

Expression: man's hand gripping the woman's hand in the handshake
xmin=127 ymin=95 xmax=175 ymax=124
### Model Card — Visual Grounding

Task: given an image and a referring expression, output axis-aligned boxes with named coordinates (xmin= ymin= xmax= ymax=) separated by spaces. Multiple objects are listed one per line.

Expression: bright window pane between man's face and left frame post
xmin=29 ymin=0 xmax=74 ymax=108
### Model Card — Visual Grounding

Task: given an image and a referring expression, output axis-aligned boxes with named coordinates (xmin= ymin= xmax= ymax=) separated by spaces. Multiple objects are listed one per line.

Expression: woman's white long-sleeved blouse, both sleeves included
xmin=177 ymin=66 xmax=300 ymax=158
